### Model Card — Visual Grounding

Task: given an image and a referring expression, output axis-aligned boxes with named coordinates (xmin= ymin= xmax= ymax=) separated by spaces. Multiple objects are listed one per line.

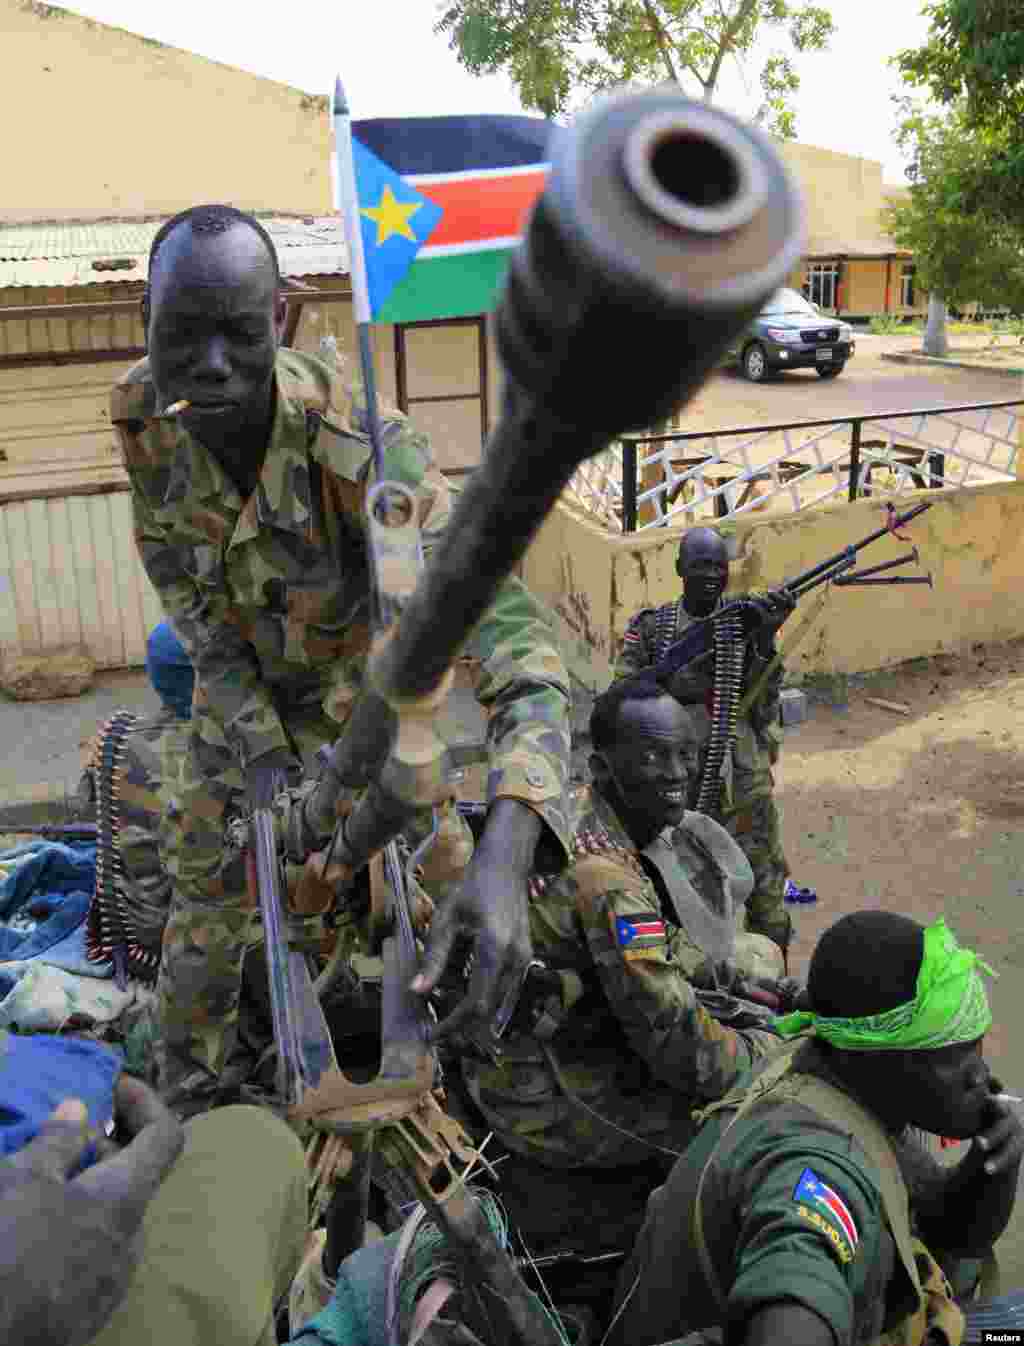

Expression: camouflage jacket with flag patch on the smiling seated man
xmin=463 ymin=790 xmax=778 ymax=1168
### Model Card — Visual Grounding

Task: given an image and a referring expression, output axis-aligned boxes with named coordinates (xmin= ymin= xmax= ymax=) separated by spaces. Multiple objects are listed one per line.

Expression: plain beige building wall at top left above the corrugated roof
xmin=0 ymin=0 xmax=332 ymax=222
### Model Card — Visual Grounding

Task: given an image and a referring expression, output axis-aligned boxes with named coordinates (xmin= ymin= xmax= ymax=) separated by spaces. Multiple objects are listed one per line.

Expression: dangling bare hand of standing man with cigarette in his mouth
xmin=412 ymin=800 xmax=542 ymax=1046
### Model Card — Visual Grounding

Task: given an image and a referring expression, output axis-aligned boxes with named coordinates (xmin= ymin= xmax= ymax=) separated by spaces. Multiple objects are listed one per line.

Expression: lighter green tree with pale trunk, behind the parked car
xmin=883 ymin=100 xmax=1024 ymax=355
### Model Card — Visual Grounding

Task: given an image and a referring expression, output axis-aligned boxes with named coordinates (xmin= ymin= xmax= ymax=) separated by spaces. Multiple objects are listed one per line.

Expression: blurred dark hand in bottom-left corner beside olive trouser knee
xmin=0 ymin=1075 xmax=184 ymax=1346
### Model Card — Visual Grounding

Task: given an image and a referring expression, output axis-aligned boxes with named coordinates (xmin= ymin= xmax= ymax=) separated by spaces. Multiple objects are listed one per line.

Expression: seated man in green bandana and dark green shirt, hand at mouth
xmin=606 ymin=911 xmax=1024 ymax=1346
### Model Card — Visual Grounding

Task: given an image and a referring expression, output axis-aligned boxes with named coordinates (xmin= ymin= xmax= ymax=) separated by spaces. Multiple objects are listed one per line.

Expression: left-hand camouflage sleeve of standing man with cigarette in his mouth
xmin=128 ymin=479 xmax=289 ymax=766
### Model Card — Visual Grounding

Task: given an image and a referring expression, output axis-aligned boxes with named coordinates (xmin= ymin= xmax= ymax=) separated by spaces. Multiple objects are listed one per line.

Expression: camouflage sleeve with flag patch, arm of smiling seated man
xmin=575 ymin=856 xmax=778 ymax=1102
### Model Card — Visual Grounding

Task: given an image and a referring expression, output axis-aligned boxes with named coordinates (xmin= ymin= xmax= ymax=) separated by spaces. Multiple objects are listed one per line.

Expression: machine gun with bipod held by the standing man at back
xmin=653 ymin=501 xmax=931 ymax=678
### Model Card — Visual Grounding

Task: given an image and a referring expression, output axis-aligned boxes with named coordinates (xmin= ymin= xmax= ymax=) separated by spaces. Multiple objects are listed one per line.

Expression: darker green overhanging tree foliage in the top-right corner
xmin=895 ymin=0 xmax=1024 ymax=222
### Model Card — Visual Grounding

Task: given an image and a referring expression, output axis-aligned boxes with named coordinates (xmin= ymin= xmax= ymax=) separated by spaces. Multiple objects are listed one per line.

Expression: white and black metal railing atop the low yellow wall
xmin=565 ymin=398 xmax=1024 ymax=533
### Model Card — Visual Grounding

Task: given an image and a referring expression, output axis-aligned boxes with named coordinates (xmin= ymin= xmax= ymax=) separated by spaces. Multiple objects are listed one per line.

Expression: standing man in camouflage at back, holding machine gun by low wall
xmin=615 ymin=528 xmax=793 ymax=952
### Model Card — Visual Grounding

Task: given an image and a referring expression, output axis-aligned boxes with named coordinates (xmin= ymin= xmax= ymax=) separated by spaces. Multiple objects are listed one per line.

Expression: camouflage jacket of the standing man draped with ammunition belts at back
xmin=615 ymin=594 xmax=784 ymax=766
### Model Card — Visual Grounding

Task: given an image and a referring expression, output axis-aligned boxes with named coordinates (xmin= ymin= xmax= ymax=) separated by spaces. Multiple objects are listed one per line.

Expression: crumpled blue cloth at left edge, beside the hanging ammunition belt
xmin=0 ymin=841 xmax=101 ymax=996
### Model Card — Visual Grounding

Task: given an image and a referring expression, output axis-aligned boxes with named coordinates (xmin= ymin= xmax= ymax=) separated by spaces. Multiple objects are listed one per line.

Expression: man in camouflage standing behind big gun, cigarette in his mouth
xmin=112 ymin=207 xmax=569 ymax=1109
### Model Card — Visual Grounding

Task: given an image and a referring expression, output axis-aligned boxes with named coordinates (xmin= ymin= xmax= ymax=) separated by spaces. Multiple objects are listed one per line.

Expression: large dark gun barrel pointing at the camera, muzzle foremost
xmin=257 ymin=90 xmax=803 ymax=1114
